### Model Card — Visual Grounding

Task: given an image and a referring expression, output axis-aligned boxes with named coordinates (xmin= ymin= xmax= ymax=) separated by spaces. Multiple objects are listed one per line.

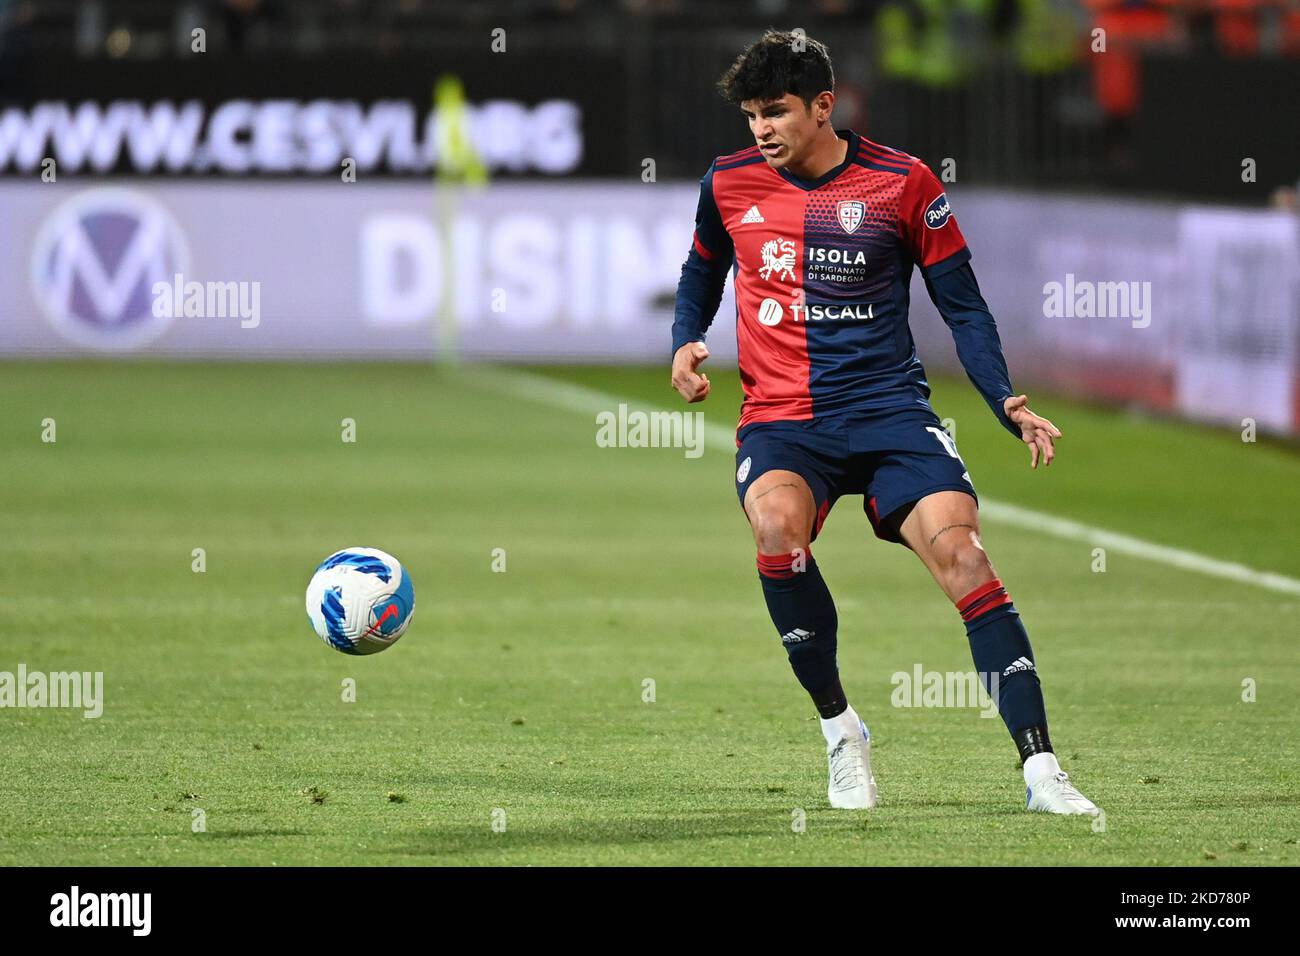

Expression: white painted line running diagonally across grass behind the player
xmin=472 ymin=367 xmax=1300 ymax=594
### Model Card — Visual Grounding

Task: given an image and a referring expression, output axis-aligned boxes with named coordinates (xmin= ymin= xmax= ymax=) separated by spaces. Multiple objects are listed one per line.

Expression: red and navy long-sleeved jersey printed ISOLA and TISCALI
xmin=673 ymin=130 xmax=1019 ymax=434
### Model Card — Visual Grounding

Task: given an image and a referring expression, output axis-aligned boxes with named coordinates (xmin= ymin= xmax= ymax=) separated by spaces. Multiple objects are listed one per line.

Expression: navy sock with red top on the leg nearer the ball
xmin=758 ymin=553 xmax=849 ymax=719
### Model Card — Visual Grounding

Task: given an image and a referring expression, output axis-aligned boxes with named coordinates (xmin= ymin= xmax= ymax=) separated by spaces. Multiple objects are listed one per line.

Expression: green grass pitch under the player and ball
xmin=0 ymin=363 xmax=1300 ymax=866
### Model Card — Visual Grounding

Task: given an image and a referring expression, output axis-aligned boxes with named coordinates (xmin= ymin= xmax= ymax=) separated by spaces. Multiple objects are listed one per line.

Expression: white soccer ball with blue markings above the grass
xmin=307 ymin=548 xmax=415 ymax=654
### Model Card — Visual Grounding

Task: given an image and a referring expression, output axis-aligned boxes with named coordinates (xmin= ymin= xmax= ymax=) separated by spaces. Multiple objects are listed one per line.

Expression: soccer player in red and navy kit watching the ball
xmin=672 ymin=31 xmax=1099 ymax=814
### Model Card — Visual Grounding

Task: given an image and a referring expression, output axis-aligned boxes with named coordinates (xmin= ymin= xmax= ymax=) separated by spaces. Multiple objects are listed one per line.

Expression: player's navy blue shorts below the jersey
xmin=736 ymin=408 xmax=979 ymax=544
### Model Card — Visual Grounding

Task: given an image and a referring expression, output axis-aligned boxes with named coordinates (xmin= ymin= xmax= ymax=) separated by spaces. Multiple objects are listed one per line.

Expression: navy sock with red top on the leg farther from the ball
xmin=957 ymin=578 xmax=1052 ymax=761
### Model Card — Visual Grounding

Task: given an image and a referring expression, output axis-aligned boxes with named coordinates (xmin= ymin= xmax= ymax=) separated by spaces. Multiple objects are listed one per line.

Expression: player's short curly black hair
xmin=718 ymin=29 xmax=835 ymax=107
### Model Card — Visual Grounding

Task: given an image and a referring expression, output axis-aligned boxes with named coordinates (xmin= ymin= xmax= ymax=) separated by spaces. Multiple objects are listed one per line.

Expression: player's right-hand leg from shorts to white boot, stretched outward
xmin=894 ymin=492 xmax=1097 ymax=814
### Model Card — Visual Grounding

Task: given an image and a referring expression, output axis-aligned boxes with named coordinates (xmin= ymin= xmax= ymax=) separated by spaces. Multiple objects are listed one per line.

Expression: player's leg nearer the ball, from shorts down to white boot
xmin=745 ymin=470 xmax=876 ymax=809
